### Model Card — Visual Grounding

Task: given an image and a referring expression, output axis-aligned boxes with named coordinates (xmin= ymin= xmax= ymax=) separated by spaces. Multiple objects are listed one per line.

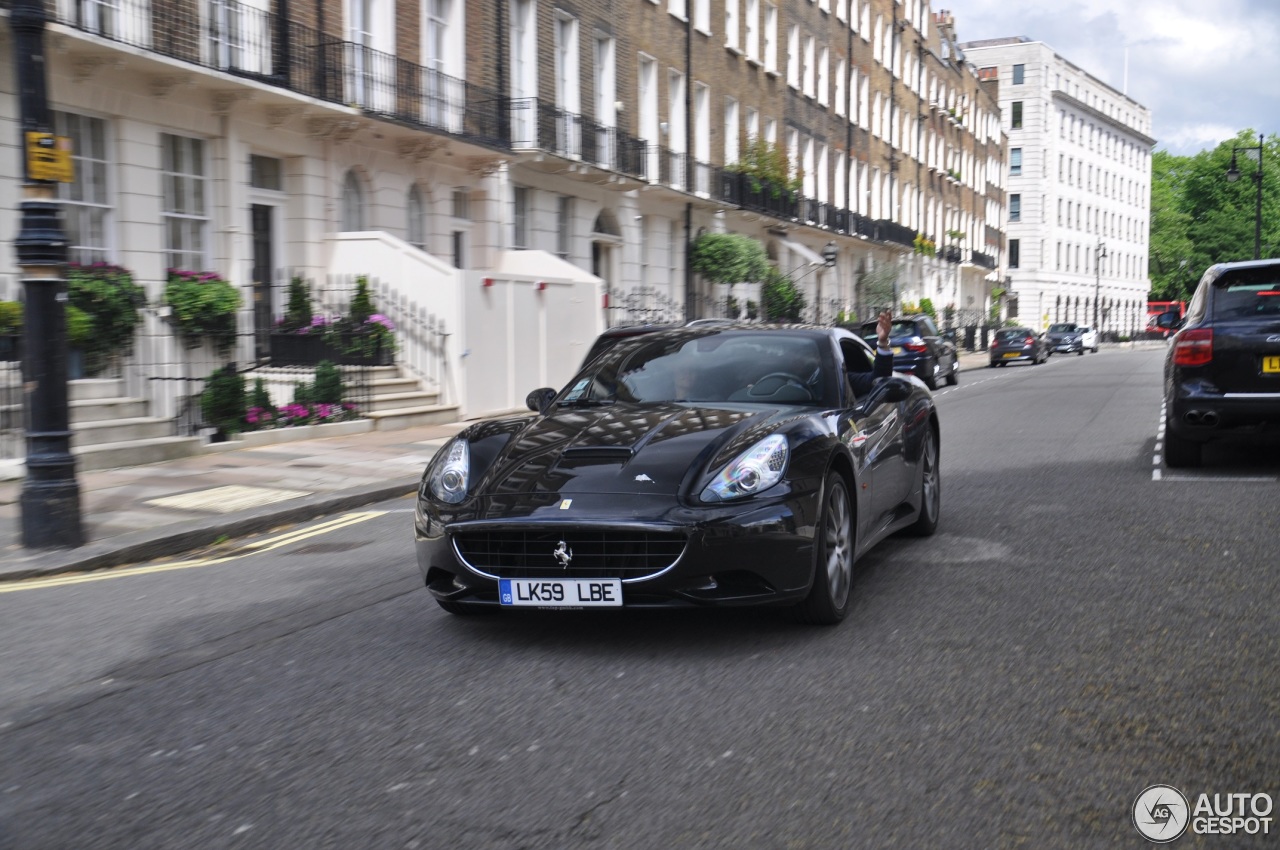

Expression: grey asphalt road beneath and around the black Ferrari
xmin=0 ymin=349 xmax=1280 ymax=850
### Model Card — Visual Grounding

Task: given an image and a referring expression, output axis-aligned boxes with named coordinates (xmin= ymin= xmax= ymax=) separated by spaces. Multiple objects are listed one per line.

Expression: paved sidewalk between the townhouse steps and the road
xmin=0 ymin=422 xmax=466 ymax=580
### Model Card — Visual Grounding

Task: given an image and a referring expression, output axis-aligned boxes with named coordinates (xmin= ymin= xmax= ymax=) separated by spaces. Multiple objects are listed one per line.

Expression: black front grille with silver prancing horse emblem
xmin=453 ymin=529 xmax=686 ymax=579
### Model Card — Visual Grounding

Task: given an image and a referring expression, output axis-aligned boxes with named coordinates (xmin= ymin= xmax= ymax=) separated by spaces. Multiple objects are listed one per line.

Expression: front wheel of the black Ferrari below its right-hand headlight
xmin=792 ymin=472 xmax=856 ymax=626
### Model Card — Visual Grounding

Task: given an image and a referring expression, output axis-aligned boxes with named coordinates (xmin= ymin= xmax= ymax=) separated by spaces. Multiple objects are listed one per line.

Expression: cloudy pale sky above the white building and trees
xmin=932 ymin=0 xmax=1280 ymax=156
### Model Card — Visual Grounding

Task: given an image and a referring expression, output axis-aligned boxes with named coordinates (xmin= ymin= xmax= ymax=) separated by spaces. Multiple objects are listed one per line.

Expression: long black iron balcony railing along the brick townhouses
xmin=15 ymin=0 xmax=967 ymax=252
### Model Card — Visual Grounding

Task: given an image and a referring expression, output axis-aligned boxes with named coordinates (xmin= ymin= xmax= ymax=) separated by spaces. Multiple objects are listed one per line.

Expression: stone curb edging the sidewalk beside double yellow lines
xmin=0 ymin=475 xmax=420 ymax=581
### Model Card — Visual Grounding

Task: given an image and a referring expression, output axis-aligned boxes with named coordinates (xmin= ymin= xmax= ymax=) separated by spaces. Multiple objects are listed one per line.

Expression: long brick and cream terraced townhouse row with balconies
xmin=0 ymin=0 xmax=1007 ymax=465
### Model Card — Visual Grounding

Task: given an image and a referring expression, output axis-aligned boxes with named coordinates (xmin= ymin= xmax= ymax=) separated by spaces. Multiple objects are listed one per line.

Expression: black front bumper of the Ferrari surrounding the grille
xmin=415 ymin=494 xmax=817 ymax=608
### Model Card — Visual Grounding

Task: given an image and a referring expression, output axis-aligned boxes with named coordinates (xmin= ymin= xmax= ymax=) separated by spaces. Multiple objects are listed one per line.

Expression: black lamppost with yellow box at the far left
xmin=9 ymin=0 xmax=83 ymax=548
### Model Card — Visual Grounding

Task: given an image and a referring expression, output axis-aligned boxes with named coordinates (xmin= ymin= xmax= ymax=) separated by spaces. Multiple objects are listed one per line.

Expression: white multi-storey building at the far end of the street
xmin=961 ymin=37 xmax=1156 ymax=334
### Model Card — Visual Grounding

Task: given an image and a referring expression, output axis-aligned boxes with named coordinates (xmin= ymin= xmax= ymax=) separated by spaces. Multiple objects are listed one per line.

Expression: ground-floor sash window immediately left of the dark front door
xmin=160 ymin=133 xmax=209 ymax=270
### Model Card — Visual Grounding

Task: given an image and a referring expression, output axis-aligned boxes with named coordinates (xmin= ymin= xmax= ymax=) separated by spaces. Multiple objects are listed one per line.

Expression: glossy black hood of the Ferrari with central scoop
xmin=463 ymin=403 xmax=797 ymax=498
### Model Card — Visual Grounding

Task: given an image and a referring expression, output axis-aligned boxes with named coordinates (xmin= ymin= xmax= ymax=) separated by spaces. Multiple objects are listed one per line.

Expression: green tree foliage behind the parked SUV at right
xmin=1149 ymin=129 xmax=1280 ymax=301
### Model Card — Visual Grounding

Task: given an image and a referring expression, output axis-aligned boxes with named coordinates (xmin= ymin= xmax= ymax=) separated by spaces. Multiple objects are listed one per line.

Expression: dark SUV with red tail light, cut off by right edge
xmin=1156 ymin=260 xmax=1280 ymax=467
